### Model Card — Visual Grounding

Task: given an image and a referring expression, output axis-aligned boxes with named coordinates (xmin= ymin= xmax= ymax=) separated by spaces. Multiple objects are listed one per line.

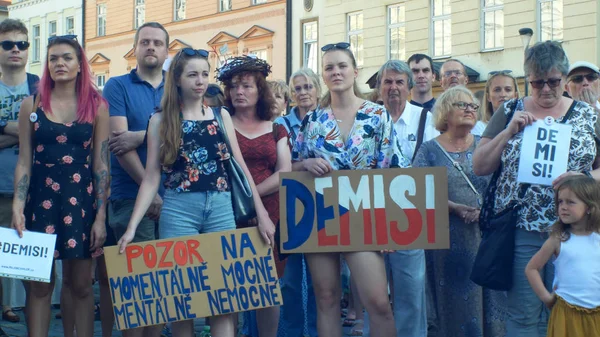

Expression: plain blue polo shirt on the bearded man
xmin=103 ymin=69 xmax=164 ymax=200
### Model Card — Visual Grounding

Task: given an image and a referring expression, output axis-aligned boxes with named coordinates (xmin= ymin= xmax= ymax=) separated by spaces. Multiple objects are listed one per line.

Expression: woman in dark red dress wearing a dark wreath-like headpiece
xmin=217 ymin=56 xmax=292 ymax=337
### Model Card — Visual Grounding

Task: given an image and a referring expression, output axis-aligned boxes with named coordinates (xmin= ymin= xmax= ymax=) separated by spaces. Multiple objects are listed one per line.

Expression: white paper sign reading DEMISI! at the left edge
xmin=0 ymin=228 xmax=56 ymax=283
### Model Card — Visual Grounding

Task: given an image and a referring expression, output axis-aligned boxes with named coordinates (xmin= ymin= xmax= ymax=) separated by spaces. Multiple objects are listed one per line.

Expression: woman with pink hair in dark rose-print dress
xmin=12 ymin=35 xmax=109 ymax=337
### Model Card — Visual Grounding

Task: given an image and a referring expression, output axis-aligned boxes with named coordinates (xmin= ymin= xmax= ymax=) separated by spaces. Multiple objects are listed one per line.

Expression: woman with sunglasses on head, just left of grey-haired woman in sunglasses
xmin=472 ymin=70 xmax=519 ymax=136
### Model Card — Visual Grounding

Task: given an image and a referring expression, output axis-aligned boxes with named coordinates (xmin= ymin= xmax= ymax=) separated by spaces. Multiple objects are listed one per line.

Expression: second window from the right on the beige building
xmin=481 ymin=0 xmax=504 ymax=50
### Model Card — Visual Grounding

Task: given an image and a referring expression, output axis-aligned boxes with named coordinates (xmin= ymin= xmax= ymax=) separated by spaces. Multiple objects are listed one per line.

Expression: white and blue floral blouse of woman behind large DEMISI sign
xmin=292 ymin=101 xmax=410 ymax=170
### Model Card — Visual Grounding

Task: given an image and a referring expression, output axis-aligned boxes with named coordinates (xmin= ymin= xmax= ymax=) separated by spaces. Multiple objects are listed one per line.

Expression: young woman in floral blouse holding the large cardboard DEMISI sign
xmin=292 ymin=42 xmax=410 ymax=337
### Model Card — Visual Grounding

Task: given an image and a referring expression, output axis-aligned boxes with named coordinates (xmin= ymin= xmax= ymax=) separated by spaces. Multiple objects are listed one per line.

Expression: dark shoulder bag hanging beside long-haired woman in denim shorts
xmin=213 ymin=107 xmax=256 ymax=223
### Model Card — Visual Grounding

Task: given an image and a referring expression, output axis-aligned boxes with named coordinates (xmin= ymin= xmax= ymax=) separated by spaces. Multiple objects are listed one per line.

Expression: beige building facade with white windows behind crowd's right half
xmin=291 ymin=0 xmax=600 ymax=92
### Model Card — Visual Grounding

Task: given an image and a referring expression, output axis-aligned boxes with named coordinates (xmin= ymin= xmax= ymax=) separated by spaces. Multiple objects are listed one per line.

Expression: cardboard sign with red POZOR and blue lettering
xmin=104 ymin=227 xmax=283 ymax=330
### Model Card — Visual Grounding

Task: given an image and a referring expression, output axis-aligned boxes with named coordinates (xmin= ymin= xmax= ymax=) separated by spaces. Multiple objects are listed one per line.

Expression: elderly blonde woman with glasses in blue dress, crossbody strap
xmin=413 ymin=86 xmax=506 ymax=337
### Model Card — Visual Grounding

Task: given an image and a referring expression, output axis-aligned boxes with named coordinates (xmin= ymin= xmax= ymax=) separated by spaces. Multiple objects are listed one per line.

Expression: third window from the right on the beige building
xmin=431 ymin=0 xmax=452 ymax=57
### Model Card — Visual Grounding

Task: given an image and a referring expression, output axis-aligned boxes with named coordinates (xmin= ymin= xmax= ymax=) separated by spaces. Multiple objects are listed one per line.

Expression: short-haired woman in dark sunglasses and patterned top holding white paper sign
xmin=473 ymin=41 xmax=600 ymax=337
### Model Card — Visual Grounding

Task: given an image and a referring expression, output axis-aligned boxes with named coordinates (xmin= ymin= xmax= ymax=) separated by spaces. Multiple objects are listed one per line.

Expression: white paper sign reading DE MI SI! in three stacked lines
xmin=517 ymin=120 xmax=572 ymax=186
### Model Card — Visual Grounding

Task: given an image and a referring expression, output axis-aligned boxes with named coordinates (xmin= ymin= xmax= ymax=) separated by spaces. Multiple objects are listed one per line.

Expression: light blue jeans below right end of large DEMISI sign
xmin=363 ymin=249 xmax=427 ymax=337
